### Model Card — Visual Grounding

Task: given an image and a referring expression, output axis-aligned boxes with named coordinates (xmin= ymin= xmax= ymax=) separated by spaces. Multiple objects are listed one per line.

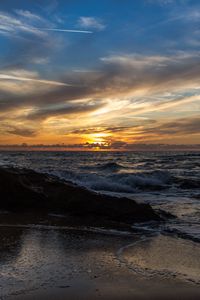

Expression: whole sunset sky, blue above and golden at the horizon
xmin=0 ymin=0 xmax=200 ymax=149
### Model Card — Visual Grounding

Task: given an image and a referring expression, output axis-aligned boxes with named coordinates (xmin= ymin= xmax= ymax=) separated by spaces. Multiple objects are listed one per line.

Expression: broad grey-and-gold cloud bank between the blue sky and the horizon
xmin=0 ymin=52 xmax=200 ymax=147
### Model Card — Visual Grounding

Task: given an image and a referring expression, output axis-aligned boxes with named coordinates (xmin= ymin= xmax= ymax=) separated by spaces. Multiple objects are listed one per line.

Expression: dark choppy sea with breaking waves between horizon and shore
xmin=0 ymin=151 xmax=200 ymax=242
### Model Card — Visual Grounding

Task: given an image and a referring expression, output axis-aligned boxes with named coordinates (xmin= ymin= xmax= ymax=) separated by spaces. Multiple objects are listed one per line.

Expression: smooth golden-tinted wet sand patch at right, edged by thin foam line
xmin=119 ymin=235 xmax=200 ymax=285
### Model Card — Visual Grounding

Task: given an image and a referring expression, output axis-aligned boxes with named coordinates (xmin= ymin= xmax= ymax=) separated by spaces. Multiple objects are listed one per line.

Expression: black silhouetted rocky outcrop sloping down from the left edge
xmin=0 ymin=168 xmax=160 ymax=224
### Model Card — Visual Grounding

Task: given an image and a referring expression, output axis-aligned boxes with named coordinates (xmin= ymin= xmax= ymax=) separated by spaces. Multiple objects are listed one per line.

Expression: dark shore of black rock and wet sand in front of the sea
xmin=0 ymin=168 xmax=200 ymax=300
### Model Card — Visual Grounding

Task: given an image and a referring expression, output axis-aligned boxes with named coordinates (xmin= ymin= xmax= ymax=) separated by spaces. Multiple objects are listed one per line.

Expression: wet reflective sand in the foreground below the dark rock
xmin=0 ymin=214 xmax=200 ymax=300
